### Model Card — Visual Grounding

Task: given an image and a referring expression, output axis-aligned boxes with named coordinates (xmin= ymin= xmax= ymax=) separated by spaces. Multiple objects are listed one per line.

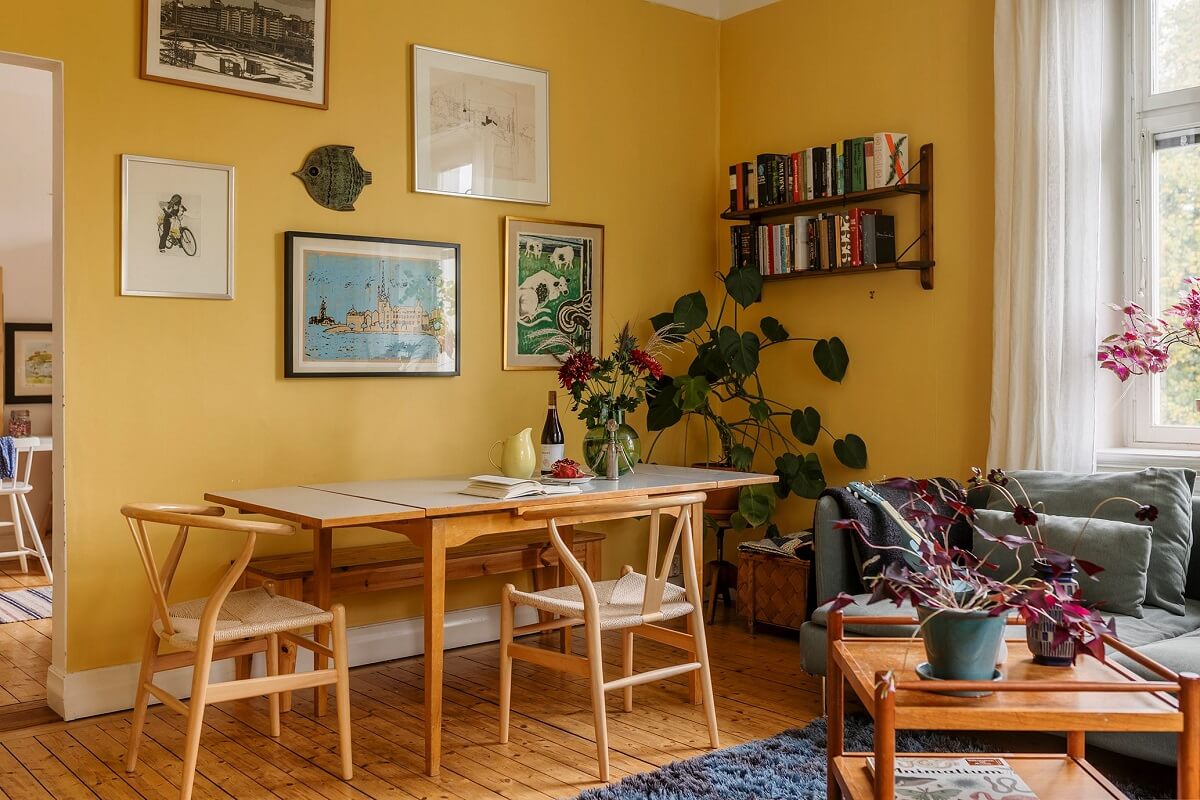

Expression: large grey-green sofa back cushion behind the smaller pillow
xmin=988 ymin=467 xmax=1195 ymax=614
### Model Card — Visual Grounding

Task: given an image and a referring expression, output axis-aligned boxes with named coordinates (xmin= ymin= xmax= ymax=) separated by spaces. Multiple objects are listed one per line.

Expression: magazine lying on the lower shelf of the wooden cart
xmin=866 ymin=756 xmax=1038 ymax=800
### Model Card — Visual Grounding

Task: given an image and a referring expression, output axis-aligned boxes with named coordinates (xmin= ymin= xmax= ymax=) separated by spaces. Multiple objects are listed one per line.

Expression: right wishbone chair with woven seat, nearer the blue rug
xmin=500 ymin=492 xmax=720 ymax=781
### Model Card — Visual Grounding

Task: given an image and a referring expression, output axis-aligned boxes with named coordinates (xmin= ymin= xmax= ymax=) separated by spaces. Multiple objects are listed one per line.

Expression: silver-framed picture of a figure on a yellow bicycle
xmin=121 ymin=156 xmax=233 ymax=300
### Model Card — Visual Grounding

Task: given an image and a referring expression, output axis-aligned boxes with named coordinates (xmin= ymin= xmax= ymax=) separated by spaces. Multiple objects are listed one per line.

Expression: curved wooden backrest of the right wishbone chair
xmin=520 ymin=492 xmax=706 ymax=622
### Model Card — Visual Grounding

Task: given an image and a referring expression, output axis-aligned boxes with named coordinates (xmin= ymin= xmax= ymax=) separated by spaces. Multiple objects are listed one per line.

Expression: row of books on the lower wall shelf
xmin=730 ymin=207 xmax=896 ymax=275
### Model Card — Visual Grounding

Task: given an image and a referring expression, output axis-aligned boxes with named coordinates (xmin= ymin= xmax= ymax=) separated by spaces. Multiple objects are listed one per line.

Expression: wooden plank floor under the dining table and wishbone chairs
xmin=0 ymin=609 xmax=821 ymax=800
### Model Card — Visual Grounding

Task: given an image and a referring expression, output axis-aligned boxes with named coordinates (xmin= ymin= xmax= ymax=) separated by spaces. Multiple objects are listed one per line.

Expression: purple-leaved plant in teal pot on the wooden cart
xmin=830 ymin=468 xmax=1158 ymax=661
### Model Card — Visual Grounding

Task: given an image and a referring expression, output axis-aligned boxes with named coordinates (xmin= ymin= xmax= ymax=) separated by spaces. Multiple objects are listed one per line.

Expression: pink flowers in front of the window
xmin=1097 ymin=277 xmax=1200 ymax=380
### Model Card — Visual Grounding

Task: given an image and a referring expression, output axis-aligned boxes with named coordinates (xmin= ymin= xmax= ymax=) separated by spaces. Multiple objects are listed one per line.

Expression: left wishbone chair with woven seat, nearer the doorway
xmin=121 ymin=504 xmax=354 ymax=800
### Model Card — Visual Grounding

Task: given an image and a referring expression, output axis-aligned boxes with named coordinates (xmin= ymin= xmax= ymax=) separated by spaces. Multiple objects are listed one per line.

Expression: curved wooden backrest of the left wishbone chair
xmin=121 ymin=503 xmax=295 ymax=638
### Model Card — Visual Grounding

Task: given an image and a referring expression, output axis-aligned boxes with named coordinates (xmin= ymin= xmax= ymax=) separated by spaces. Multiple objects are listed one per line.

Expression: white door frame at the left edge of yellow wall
xmin=0 ymin=50 xmax=71 ymax=720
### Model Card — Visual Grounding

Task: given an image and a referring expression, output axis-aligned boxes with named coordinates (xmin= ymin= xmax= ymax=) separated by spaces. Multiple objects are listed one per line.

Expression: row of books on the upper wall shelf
xmin=730 ymin=131 xmax=908 ymax=211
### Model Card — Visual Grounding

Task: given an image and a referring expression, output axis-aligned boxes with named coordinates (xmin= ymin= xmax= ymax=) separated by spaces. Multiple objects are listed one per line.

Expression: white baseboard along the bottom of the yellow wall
xmin=46 ymin=604 xmax=536 ymax=720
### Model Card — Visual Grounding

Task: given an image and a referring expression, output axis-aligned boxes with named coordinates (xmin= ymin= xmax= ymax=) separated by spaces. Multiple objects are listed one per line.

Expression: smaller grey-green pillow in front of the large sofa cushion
xmin=971 ymin=509 xmax=1152 ymax=619
